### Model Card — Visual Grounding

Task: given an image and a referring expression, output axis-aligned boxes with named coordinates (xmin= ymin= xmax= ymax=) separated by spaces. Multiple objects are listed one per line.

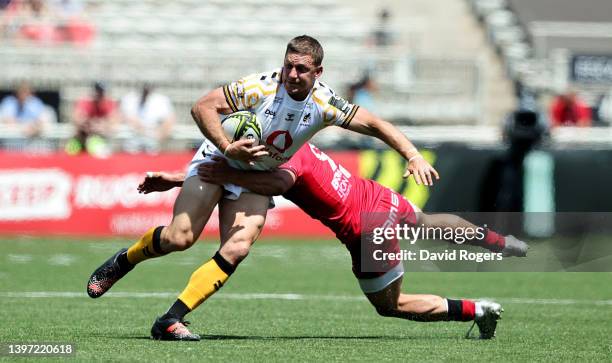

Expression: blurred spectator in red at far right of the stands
xmin=550 ymin=91 xmax=592 ymax=127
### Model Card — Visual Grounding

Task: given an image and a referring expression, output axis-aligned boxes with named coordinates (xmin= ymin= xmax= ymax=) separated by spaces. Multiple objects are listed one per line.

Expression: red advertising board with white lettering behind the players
xmin=0 ymin=152 xmax=358 ymax=237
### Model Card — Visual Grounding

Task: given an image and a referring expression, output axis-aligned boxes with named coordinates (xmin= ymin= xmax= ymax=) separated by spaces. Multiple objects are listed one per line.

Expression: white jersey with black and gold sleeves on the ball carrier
xmin=223 ymin=69 xmax=359 ymax=170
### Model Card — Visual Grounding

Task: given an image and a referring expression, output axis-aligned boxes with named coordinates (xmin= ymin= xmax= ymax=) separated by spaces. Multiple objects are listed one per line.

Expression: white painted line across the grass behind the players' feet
xmin=0 ymin=291 xmax=612 ymax=305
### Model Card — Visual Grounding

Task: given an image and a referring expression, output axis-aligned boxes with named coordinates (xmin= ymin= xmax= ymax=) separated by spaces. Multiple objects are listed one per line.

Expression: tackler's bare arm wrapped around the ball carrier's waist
xmin=198 ymin=157 xmax=296 ymax=196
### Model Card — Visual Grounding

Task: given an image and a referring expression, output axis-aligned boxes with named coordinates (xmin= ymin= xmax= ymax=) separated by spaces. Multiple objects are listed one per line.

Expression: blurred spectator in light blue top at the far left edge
xmin=0 ymin=83 xmax=51 ymax=139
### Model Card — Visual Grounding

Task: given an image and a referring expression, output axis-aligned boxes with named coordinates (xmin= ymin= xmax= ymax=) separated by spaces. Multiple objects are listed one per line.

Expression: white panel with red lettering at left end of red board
xmin=0 ymin=169 xmax=72 ymax=221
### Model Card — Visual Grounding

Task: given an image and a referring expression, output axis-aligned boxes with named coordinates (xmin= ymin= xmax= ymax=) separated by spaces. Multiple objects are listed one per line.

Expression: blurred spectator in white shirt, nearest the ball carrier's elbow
xmin=121 ymin=85 xmax=176 ymax=153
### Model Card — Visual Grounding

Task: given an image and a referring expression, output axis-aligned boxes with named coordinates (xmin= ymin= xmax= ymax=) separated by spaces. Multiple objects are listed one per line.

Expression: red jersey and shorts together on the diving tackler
xmin=280 ymin=144 xmax=417 ymax=278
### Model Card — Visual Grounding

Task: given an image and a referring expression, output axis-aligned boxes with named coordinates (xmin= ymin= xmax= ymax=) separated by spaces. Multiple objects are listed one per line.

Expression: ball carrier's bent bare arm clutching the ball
xmin=191 ymin=87 xmax=268 ymax=162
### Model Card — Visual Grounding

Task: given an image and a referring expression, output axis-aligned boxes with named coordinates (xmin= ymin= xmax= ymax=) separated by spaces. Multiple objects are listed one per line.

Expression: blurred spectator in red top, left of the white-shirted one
xmin=66 ymin=82 xmax=118 ymax=157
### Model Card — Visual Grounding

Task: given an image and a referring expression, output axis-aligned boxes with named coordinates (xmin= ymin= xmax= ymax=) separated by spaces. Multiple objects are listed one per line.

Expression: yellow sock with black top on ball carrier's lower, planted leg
xmin=178 ymin=252 xmax=234 ymax=310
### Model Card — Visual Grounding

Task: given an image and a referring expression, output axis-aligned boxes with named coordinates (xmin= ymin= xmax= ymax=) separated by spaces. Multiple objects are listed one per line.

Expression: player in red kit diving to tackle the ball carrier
xmin=138 ymin=144 xmax=528 ymax=339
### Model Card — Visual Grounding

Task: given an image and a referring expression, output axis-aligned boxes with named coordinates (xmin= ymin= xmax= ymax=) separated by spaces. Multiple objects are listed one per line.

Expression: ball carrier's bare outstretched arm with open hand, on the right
xmin=347 ymin=107 xmax=440 ymax=185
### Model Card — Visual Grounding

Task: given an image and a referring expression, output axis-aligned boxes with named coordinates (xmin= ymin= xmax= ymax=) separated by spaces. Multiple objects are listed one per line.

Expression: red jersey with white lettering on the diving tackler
xmin=280 ymin=144 xmax=390 ymax=242
